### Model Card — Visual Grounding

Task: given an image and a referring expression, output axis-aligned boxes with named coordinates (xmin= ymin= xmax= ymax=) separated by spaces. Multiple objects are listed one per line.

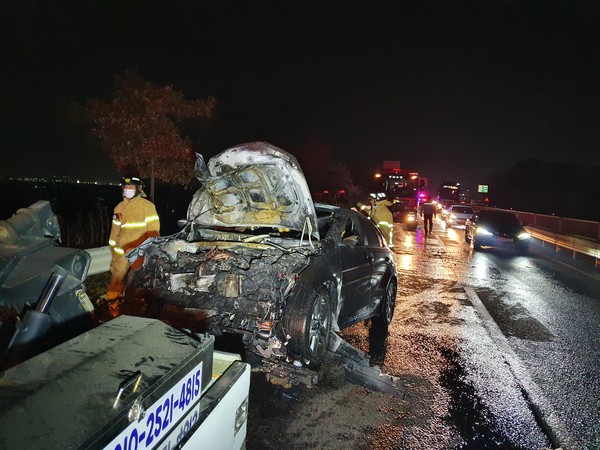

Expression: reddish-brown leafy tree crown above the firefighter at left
xmin=83 ymin=71 xmax=216 ymax=198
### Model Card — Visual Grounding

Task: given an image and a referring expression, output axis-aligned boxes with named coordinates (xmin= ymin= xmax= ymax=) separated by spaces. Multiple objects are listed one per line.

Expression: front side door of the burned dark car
xmin=336 ymin=215 xmax=372 ymax=327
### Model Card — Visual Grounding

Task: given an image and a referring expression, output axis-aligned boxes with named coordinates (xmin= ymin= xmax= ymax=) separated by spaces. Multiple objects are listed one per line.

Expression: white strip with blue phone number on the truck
xmin=105 ymin=361 xmax=202 ymax=450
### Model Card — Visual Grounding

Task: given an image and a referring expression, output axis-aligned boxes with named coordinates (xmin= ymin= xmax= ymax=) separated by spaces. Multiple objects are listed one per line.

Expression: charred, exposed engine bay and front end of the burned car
xmin=127 ymin=235 xmax=320 ymax=358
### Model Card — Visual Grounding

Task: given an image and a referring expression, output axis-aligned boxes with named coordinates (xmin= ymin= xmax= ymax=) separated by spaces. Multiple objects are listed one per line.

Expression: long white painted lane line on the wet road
xmin=463 ymin=286 xmax=575 ymax=447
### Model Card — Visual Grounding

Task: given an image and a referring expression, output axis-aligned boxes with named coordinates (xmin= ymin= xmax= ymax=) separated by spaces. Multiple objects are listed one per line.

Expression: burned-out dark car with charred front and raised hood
xmin=125 ymin=142 xmax=397 ymax=367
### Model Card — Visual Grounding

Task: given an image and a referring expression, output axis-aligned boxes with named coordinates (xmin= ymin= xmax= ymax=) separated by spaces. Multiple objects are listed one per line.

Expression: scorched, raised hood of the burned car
xmin=187 ymin=142 xmax=319 ymax=239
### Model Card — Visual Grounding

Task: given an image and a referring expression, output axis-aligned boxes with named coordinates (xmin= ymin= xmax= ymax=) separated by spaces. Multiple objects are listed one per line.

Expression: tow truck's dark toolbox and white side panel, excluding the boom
xmin=0 ymin=316 xmax=250 ymax=450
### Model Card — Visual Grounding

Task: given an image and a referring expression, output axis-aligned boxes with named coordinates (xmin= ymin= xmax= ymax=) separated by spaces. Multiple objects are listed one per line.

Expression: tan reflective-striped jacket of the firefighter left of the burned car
xmin=108 ymin=195 xmax=160 ymax=255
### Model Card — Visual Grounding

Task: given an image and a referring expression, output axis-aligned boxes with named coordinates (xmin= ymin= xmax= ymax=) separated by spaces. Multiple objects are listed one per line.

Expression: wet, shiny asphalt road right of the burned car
xmin=246 ymin=220 xmax=600 ymax=449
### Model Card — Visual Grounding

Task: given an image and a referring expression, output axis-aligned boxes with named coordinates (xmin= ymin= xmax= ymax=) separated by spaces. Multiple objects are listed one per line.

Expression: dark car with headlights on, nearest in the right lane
xmin=465 ymin=210 xmax=531 ymax=254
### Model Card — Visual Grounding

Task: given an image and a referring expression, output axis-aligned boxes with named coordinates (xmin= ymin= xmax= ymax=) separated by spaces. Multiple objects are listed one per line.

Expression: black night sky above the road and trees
xmin=0 ymin=0 xmax=600 ymax=192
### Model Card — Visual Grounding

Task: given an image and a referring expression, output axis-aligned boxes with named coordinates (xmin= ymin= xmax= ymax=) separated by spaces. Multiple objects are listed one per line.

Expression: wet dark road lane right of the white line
xmin=464 ymin=237 xmax=600 ymax=449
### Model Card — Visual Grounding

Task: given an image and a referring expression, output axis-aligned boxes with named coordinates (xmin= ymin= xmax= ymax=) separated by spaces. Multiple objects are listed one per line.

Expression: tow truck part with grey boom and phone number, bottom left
xmin=0 ymin=201 xmax=250 ymax=450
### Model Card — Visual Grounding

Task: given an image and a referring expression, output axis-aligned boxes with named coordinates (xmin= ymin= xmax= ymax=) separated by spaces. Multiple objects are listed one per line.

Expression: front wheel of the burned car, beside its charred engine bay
xmin=283 ymin=286 xmax=332 ymax=367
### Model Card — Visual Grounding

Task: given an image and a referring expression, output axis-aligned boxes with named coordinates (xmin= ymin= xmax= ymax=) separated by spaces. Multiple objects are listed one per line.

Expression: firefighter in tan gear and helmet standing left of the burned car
xmin=106 ymin=177 xmax=160 ymax=317
